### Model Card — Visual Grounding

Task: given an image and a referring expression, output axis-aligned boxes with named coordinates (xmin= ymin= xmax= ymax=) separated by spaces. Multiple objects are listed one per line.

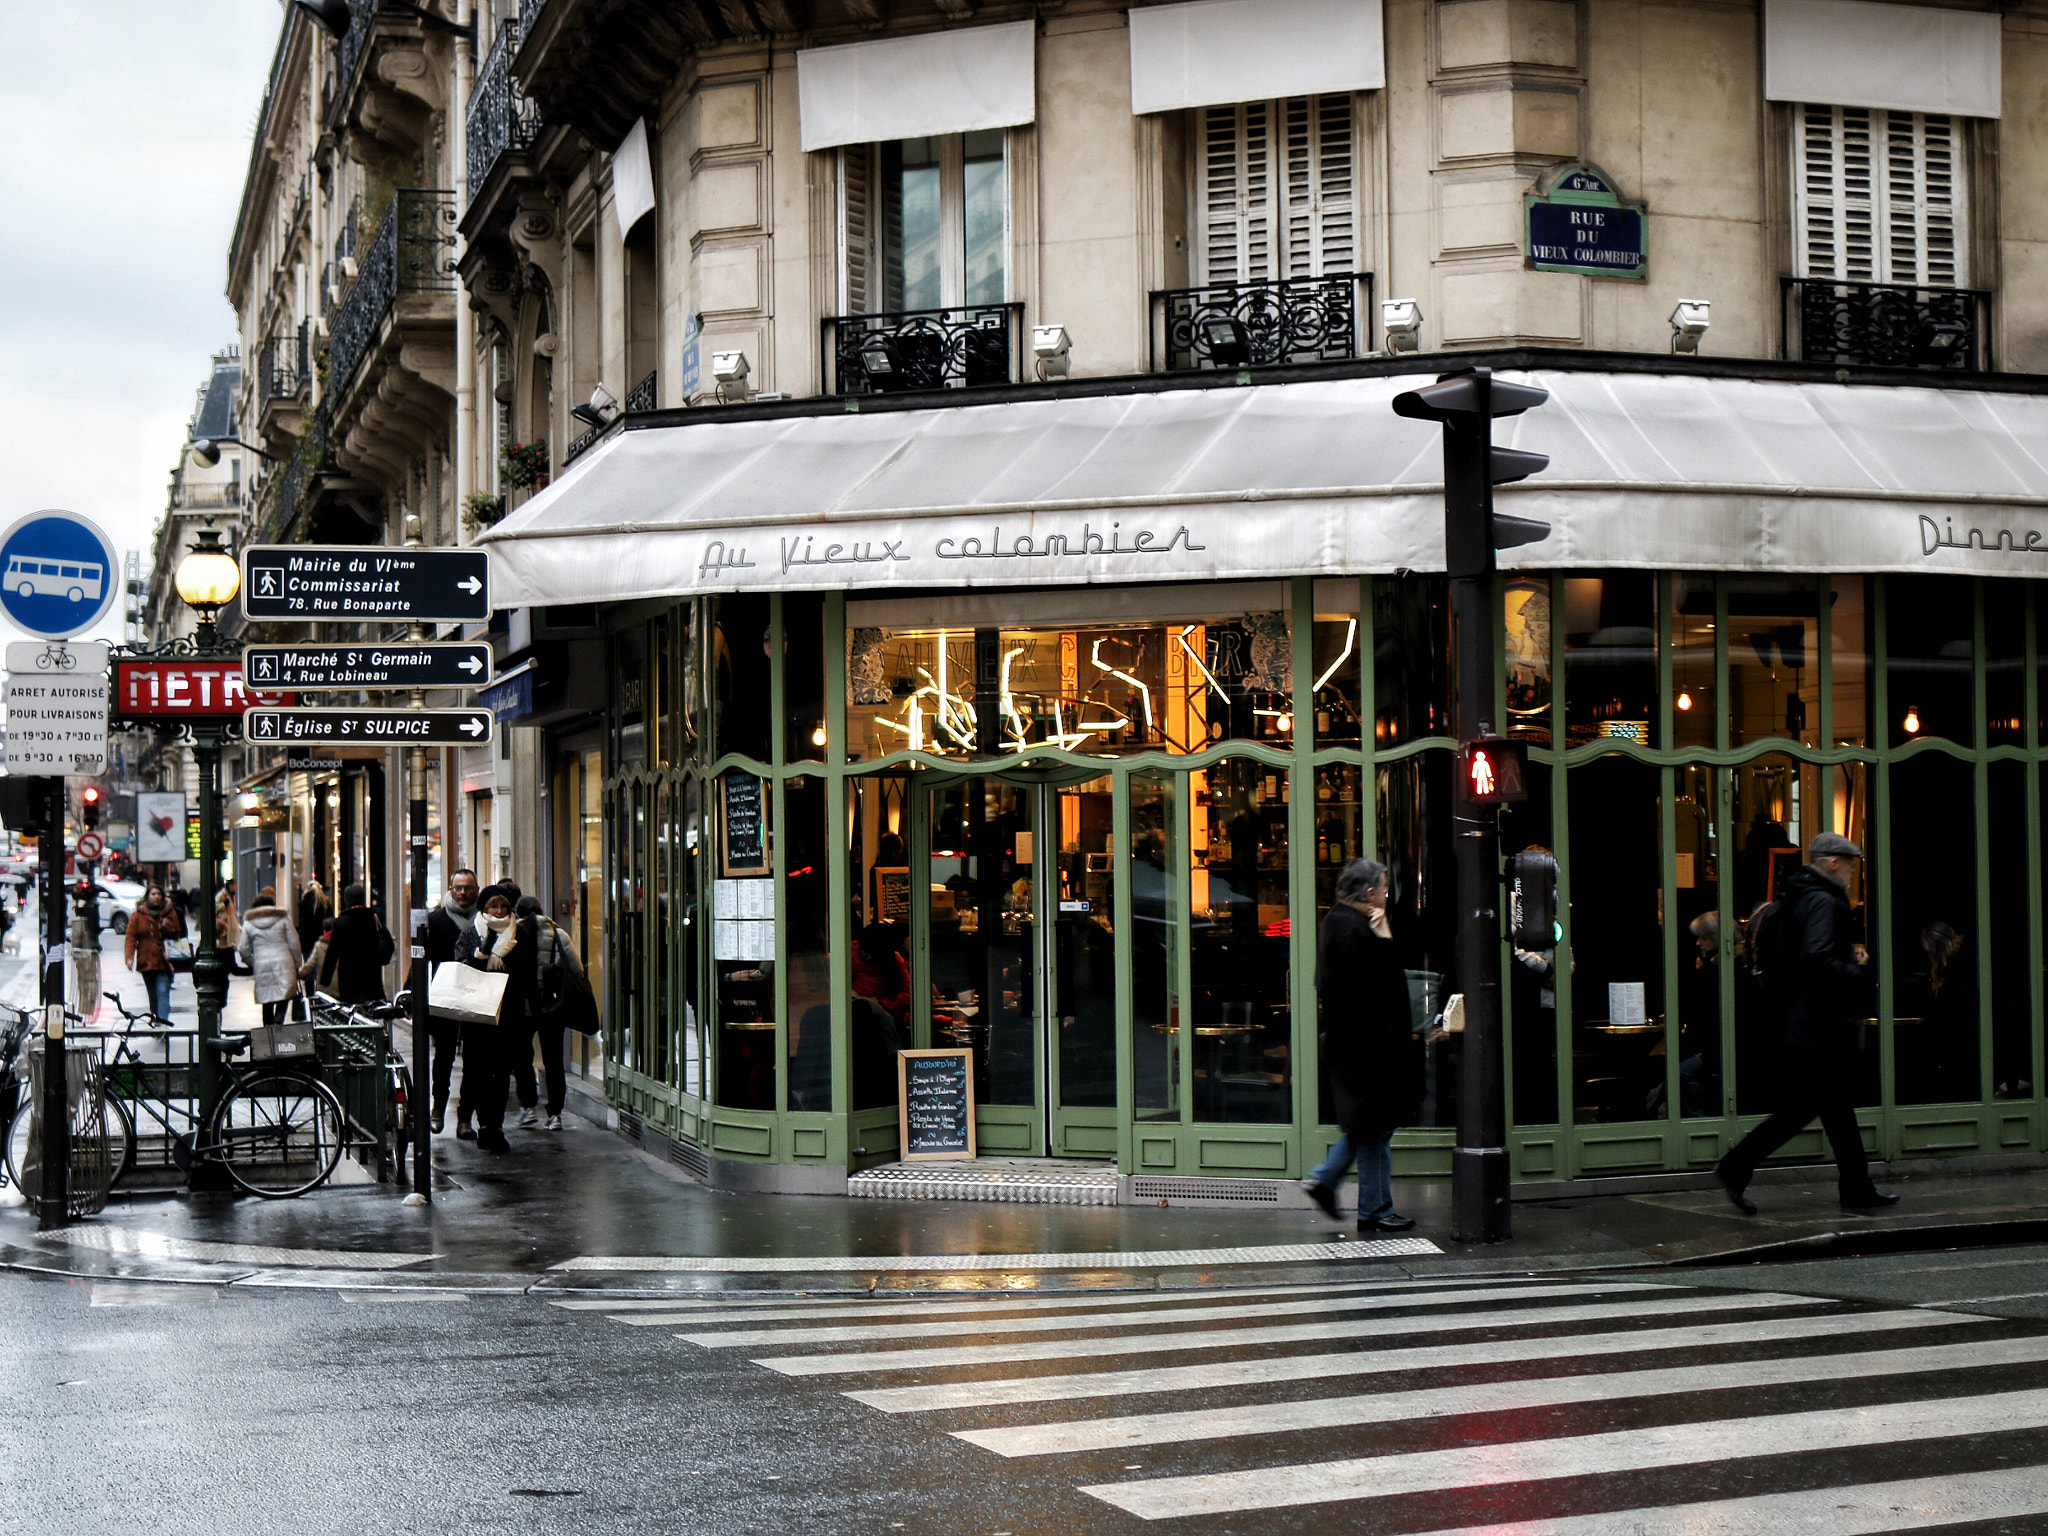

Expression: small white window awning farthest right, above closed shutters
xmin=1763 ymin=0 xmax=2003 ymax=117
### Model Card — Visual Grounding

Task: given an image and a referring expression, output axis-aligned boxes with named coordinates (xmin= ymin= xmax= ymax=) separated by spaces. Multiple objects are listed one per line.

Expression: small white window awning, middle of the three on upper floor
xmin=1130 ymin=0 xmax=1386 ymax=115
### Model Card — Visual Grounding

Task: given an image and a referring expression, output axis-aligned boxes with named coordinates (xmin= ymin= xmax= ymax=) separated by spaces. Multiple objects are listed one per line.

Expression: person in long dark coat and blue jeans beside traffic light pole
xmin=1303 ymin=858 xmax=1423 ymax=1233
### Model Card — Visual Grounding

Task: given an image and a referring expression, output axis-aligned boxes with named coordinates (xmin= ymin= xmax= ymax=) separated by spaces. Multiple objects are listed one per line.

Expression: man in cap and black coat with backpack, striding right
xmin=1714 ymin=831 xmax=1898 ymax=1217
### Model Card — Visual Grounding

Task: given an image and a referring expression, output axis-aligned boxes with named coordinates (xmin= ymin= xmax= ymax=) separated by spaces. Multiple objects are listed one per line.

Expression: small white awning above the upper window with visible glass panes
xmin=797 ymin=20 xmax=1038 ymax=150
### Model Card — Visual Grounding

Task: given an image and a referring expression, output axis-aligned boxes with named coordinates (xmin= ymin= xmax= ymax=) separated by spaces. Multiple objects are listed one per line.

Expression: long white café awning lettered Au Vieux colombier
xmin=479 ymin=371 xmax=2048 ymax=606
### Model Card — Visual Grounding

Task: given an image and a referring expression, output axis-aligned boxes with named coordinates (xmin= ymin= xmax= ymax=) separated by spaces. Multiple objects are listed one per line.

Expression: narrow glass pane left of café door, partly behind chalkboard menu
xmin=846 ymin=776 xmax=918 ymax=1110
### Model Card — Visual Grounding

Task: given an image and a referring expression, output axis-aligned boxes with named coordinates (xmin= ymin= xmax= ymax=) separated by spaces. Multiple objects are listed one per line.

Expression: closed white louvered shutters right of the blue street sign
xmin=1794 ymin=104 xmax=1968 ymax=287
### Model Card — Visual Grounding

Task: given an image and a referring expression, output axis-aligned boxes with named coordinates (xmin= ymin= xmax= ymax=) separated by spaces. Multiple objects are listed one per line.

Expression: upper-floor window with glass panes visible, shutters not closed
xmin=840 ymin=129 xmax=1010 ymax=315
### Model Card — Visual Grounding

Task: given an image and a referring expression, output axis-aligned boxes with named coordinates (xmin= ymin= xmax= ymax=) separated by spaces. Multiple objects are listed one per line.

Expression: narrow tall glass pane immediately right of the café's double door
xmin=1130 ymin=774 xmax=1188 ymax=1120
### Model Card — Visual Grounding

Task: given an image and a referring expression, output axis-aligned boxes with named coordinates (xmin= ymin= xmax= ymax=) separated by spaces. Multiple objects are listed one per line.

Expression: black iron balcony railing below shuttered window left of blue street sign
xmin=1151 ymin=272 xmax=1372 ymax=373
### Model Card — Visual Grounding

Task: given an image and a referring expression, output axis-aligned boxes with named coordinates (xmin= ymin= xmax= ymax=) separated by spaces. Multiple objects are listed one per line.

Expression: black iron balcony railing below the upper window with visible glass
xmin=823 ymin=303 xmax=1024 ymax=395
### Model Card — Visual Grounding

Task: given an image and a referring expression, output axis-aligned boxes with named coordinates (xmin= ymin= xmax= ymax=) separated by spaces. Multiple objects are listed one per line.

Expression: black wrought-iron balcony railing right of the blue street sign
xmin=1784 ymin=276 xmax=1991 ymax=371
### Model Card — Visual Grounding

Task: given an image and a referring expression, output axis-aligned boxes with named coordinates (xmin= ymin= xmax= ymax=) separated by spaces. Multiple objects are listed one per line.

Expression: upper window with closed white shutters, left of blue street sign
xmin=1194 ymin=94 xmax=1358 ymax=285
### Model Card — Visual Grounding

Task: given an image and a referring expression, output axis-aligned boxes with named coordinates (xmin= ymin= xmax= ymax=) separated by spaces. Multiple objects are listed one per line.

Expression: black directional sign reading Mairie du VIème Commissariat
xmin=242 ymin=545 xmax=492 ymax=623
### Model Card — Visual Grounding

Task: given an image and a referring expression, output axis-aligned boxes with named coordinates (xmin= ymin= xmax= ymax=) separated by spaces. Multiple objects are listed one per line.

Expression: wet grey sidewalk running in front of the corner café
xmin=0 ymin=942 xmax=2048 ymax=1294
